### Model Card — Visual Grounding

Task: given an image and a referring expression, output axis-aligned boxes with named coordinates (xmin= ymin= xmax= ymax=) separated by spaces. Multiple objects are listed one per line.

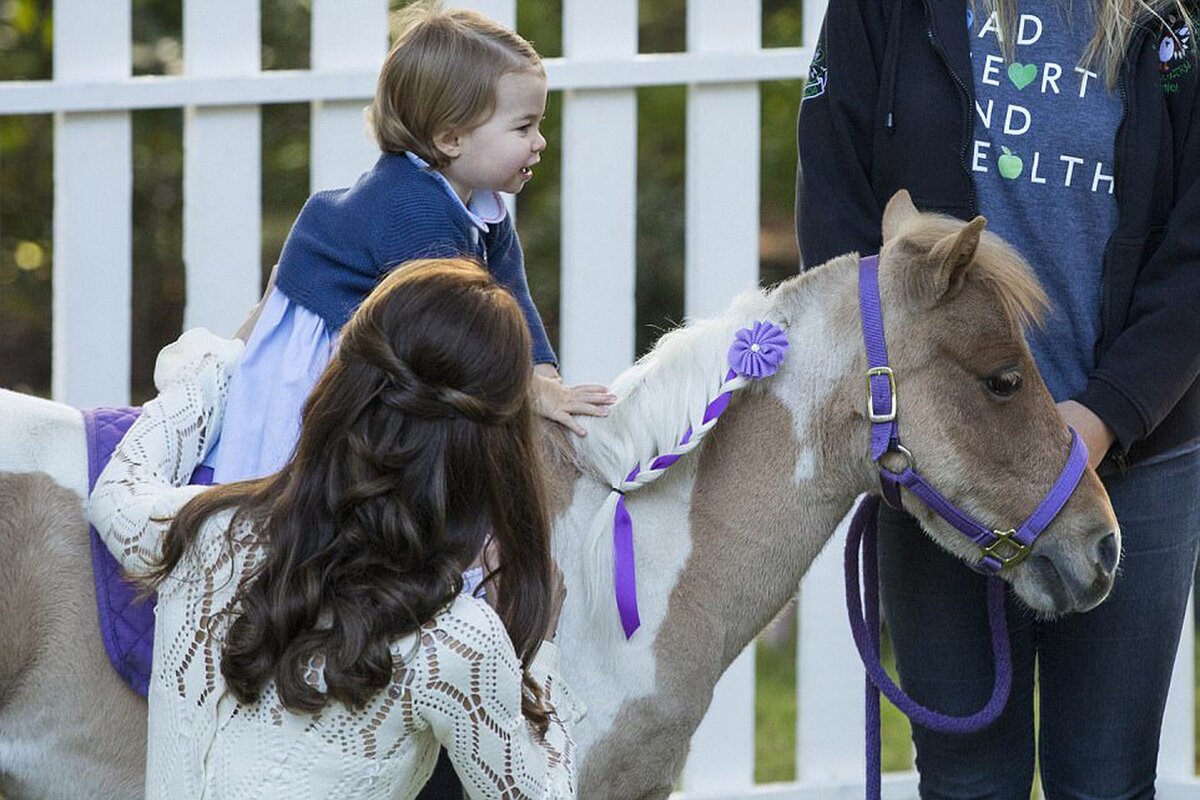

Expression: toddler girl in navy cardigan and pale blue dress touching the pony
xmin=205 ymin=1 xmax=614 ymax=483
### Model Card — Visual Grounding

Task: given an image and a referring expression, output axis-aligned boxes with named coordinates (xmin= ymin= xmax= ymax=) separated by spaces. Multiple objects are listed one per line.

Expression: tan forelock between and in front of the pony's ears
xmin=900 ymin=213 xmax=1050 ymax=330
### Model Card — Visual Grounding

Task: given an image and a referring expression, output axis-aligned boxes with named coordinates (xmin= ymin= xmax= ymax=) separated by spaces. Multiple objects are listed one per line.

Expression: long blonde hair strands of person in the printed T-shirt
xmin=983 ymin=0 xmax=1195 ymax=89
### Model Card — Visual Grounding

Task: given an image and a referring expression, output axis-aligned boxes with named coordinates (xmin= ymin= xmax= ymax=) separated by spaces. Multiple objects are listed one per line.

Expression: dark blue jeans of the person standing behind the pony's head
xmin=880 ymin=450 xmax=1200 ymax=800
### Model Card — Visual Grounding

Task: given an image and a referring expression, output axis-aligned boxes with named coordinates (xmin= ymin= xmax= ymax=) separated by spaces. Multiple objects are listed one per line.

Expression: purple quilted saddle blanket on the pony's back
xmin=83 ymin=408 xmax=212 ymax=697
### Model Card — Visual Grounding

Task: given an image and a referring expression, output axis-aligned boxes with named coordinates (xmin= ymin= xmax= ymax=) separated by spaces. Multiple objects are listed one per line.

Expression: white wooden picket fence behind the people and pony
xmin=0 ymin=0 xmax=1200 ymax=800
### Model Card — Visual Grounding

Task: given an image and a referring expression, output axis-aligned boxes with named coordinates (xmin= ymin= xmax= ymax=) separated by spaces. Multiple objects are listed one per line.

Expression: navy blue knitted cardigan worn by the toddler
xmin=275 ymin=154 xmax=557 ymax=363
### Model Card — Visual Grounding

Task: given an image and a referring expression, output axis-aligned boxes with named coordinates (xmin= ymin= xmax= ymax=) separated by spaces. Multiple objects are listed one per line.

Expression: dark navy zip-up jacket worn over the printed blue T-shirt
xmin=796 ymin=0 xmax=1200 ymax=462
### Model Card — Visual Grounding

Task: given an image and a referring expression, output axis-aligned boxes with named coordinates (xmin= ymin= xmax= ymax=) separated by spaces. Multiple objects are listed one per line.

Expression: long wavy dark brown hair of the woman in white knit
xmin=150 ymin=259 xmax=551 ymax=729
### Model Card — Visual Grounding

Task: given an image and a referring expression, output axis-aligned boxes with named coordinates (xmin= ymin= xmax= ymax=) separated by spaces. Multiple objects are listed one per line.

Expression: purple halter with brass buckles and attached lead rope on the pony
xmin=846 ymin=255 xmax=1087 ymax=800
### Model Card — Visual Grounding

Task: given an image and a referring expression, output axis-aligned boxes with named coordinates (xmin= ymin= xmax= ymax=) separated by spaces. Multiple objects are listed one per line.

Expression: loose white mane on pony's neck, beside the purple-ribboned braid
xmin=577 ymin=290 xmax=770 ymax=485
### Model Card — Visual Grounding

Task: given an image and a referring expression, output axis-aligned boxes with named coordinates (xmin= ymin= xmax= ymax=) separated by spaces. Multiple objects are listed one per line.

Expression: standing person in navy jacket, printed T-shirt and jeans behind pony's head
xmin=796 ymin=0 xmax=1200 ymax=799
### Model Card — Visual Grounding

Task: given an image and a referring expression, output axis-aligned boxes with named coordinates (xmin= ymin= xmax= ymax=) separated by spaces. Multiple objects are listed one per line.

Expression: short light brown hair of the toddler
xmin=367 ymin=0 xmax=545 ymax=168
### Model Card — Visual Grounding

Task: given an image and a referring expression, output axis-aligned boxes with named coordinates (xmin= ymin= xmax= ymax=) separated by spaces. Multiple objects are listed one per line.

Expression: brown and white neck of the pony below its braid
xmin=556 ymin=258 xmax=870 ymax=796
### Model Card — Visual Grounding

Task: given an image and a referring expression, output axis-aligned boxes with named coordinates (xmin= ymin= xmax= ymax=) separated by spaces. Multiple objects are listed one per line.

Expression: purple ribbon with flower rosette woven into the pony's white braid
xmin=612 ymin=321 xmax=787 ymax=639
